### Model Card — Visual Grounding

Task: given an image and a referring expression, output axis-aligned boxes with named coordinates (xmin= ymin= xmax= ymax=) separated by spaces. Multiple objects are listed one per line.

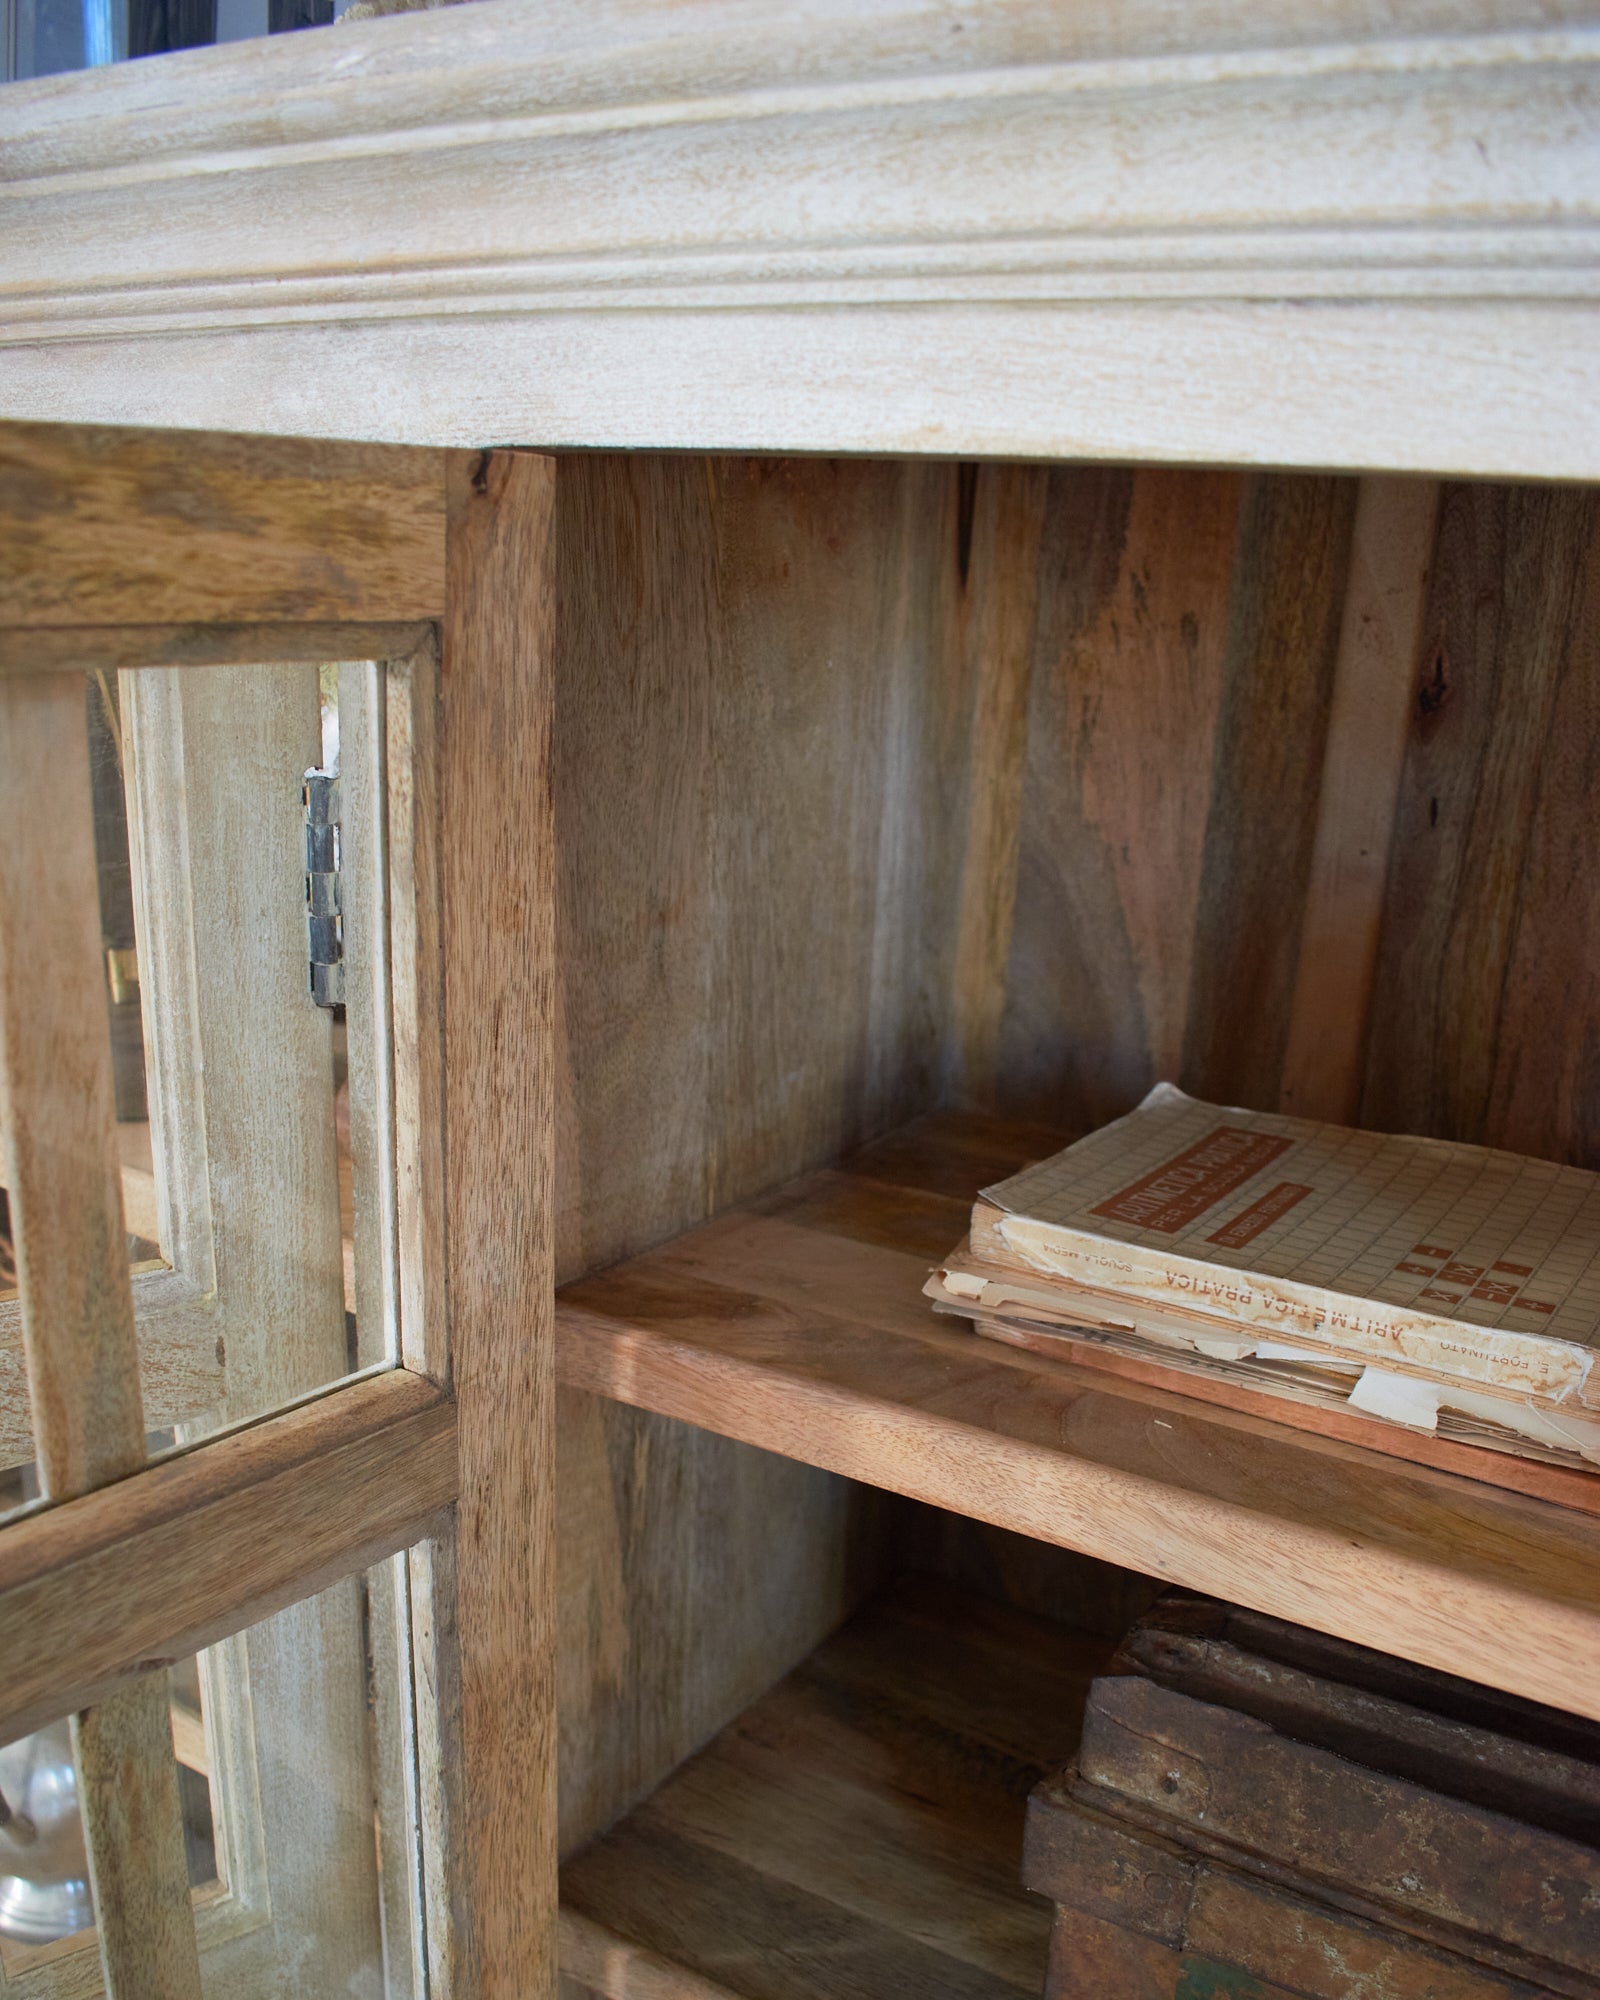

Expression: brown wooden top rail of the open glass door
xmin=0 ymin=424 xmax=444 ymax=626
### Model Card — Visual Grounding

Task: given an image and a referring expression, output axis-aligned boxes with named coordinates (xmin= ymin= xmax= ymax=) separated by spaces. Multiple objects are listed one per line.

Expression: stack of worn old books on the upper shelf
xmin=928 ymin=1084 xmax=1600 ymax=1466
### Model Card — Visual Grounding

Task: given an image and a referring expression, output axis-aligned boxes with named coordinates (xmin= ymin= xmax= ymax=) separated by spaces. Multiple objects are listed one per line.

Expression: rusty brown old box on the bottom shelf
xmin=1024 ymin=1594 xmax=1600 ymax=2000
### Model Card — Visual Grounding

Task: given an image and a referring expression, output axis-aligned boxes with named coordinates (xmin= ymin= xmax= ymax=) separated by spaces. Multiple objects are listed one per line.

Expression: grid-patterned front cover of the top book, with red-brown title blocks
xmin=986 ymin=1084 xmax=1600 ymax=1344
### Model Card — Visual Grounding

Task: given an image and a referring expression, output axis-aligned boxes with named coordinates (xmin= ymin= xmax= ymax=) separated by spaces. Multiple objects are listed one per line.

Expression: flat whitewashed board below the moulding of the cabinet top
xmin=0 ymin=300 xmax=1600 ymax=480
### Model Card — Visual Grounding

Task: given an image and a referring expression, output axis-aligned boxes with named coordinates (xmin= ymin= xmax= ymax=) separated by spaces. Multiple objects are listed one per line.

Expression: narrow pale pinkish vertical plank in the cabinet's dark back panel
xmin=1278 ymin=478 xmax=1438 ymax=1124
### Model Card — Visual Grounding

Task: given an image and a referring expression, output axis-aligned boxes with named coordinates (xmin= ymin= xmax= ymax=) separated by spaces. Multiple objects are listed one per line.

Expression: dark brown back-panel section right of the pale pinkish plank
xmin=1360 ymin=486 xmax=1600 ymax=1168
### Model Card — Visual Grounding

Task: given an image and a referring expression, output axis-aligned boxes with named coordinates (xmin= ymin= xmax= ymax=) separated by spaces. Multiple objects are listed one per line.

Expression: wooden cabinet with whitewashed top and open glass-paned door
xmin=0 ymin=0 xmax=1600 ymax=2000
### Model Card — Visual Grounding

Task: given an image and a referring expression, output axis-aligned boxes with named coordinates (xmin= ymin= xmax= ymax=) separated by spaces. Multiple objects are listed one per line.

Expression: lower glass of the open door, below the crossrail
xmin=0 ymin=1562 xmax=406 ymax=2000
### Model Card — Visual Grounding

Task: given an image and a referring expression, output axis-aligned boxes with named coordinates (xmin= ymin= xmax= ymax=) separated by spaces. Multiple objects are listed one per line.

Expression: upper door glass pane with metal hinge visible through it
xmin=122 ymin=662 xmax=394 ymax=1442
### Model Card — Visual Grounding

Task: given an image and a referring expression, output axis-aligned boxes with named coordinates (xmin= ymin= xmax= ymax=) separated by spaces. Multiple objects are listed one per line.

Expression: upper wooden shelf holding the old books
xmin=558 ymin=1114 xmax=1600 ymax=1718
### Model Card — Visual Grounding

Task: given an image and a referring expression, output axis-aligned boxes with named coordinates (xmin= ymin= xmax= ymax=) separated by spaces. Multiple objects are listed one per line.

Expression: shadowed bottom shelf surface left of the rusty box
xmin=562 ymin=1580 xmax=1110 ymax=2000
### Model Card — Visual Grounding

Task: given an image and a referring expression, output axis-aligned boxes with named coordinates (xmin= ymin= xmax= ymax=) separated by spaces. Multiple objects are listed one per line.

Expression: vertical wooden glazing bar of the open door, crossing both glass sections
xmin=0 ymin=676 xmax=200 ymax=2000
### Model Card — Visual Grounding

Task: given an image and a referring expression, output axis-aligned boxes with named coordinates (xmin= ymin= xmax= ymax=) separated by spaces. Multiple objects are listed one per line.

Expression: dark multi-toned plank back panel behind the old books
xmin=976 ymin=468 xmax=1600 ymax=1166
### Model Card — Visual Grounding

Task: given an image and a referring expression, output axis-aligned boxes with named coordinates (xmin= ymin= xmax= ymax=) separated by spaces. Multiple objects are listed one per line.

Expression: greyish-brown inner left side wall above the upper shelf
xmin=556 ymin=458 xmax=970 ymax=1276
